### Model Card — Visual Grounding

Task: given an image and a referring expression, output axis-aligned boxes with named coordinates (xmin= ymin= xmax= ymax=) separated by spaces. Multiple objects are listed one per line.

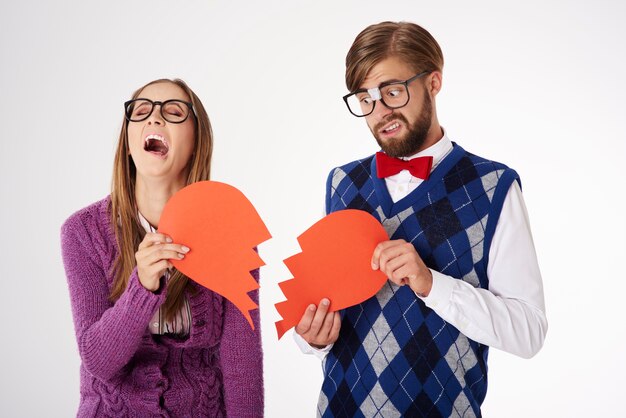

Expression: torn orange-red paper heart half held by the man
xmin=275 ymin=209 xmax=388 ymax=339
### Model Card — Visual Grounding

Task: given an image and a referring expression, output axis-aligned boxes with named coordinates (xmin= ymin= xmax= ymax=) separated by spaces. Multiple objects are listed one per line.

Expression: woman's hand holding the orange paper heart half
xmin=135 ymin=233 xmax=189 ymax=292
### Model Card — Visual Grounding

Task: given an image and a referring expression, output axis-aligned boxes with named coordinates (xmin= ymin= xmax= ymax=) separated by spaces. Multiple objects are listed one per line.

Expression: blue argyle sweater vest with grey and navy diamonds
xmin=318 ymin=144 xmax=519 ymax=417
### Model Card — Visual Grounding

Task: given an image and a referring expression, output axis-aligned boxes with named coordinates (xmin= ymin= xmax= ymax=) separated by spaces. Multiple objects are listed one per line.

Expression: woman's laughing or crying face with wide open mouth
xmin=128 ymin=82 xmax=196 ymax=184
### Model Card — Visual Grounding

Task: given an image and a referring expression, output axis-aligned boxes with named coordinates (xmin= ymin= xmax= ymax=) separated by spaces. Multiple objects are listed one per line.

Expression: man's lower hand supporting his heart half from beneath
xmin=296 ymin=298 xmax=341 ymax=348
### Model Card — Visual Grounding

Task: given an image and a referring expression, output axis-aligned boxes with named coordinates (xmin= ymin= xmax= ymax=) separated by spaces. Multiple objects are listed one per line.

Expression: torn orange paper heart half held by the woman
xmin=159 ymin=181 xmax=271 ymax=328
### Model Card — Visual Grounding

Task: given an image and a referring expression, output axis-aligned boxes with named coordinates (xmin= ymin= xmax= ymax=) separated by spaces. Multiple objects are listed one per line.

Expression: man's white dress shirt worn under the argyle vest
xmin=293 ymin=131 xmax=548 ymax=358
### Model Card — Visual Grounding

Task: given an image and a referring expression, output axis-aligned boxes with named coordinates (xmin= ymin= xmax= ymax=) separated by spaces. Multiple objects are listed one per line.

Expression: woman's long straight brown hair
xmin=109 ymin=79 xmax=213 ymax=319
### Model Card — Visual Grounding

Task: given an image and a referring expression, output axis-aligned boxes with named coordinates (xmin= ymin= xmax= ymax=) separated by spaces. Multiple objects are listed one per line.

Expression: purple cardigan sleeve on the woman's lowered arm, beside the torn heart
xmin=220 ymin=270 xmax=264 ymax=417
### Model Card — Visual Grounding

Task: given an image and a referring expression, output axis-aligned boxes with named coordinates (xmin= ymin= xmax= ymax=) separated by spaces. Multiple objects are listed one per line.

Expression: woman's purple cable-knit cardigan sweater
xmin=61 ymin=197 xmax=263 ymax=417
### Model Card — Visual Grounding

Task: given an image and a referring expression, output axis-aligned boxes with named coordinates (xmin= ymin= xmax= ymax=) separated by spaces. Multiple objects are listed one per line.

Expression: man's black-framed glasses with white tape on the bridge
xmin=343 ymin=71 xmax=429 ymax=118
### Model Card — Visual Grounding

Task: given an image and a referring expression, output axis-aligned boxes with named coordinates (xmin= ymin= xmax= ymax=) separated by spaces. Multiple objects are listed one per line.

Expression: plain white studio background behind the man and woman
xmin=0 ymin=0 xmax=626 ymax=417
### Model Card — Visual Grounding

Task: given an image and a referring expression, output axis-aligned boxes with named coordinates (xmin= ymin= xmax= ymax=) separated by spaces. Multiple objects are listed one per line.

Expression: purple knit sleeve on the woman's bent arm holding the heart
xmin=61 ymin=213 xmax=165 ymax=381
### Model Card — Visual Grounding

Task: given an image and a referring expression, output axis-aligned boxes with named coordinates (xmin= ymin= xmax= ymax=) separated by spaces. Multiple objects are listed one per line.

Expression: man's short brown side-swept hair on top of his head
xmin=346 ymin=22 xmax=443 ymax=91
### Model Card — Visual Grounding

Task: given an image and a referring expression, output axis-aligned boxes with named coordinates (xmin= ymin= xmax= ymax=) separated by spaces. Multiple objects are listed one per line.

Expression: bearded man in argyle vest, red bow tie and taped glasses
xmin=294 ymin=22 xmax=547 ymax=417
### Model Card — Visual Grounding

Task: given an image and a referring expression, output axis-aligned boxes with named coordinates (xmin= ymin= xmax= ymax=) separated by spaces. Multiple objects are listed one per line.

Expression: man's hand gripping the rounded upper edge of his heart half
xmin=372 ymin=239 xmax=433 ymax=297
